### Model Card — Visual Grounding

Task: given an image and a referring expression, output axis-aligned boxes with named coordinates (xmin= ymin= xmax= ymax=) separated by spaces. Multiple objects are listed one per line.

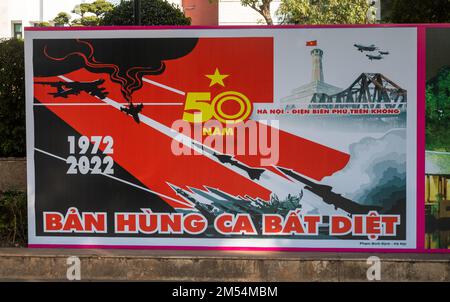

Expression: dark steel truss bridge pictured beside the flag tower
xmin=310 ymin=73 xmax=407 ymax=111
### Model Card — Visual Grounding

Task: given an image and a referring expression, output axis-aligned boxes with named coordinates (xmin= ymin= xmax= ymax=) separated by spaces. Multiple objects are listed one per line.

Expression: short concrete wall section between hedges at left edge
xmin=0 ymin=157 xmax=27 ymax=191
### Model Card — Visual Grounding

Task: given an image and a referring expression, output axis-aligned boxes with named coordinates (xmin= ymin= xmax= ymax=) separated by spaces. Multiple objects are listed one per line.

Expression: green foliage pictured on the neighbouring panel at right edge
xmin=426 ymin=67 xmax=450 ymax=151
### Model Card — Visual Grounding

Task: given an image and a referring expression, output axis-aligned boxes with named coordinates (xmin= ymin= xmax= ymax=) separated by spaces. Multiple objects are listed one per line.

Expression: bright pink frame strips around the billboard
xmin=25 ymin=23 xmax=450 ymax=253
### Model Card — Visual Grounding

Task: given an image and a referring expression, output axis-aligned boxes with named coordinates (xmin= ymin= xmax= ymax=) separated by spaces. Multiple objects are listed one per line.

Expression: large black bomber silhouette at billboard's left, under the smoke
xmin=34 ymin=79 xmax=108 ymax=99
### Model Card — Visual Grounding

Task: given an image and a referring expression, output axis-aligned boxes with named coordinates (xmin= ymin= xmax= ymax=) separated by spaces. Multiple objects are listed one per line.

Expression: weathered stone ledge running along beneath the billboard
xmin=0 ymin=248 xmax=450 ymax=281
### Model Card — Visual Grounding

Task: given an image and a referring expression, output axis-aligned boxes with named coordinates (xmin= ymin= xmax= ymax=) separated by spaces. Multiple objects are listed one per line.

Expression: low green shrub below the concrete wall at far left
xmin=0 ymin=191 xmax=27 ymax=246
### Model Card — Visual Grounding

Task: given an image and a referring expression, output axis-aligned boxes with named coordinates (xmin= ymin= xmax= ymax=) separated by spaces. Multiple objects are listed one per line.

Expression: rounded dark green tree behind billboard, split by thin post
xmin=100 ymin=0 xmax=191 ymax=25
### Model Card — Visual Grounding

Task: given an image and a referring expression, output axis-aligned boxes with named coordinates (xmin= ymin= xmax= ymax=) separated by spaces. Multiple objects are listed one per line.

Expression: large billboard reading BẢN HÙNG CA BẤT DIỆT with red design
xmin=25 ymin=26 xmax=424 ymax=251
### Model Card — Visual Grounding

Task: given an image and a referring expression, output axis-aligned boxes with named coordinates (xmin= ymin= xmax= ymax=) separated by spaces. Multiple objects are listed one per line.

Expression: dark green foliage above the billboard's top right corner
xmin=381 ymin=0 xmax=450 ymax=23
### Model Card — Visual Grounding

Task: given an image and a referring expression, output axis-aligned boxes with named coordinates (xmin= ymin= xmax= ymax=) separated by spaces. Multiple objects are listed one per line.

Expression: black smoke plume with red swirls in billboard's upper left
xmin=33 ymin=38 xmax=198 ymax=102
